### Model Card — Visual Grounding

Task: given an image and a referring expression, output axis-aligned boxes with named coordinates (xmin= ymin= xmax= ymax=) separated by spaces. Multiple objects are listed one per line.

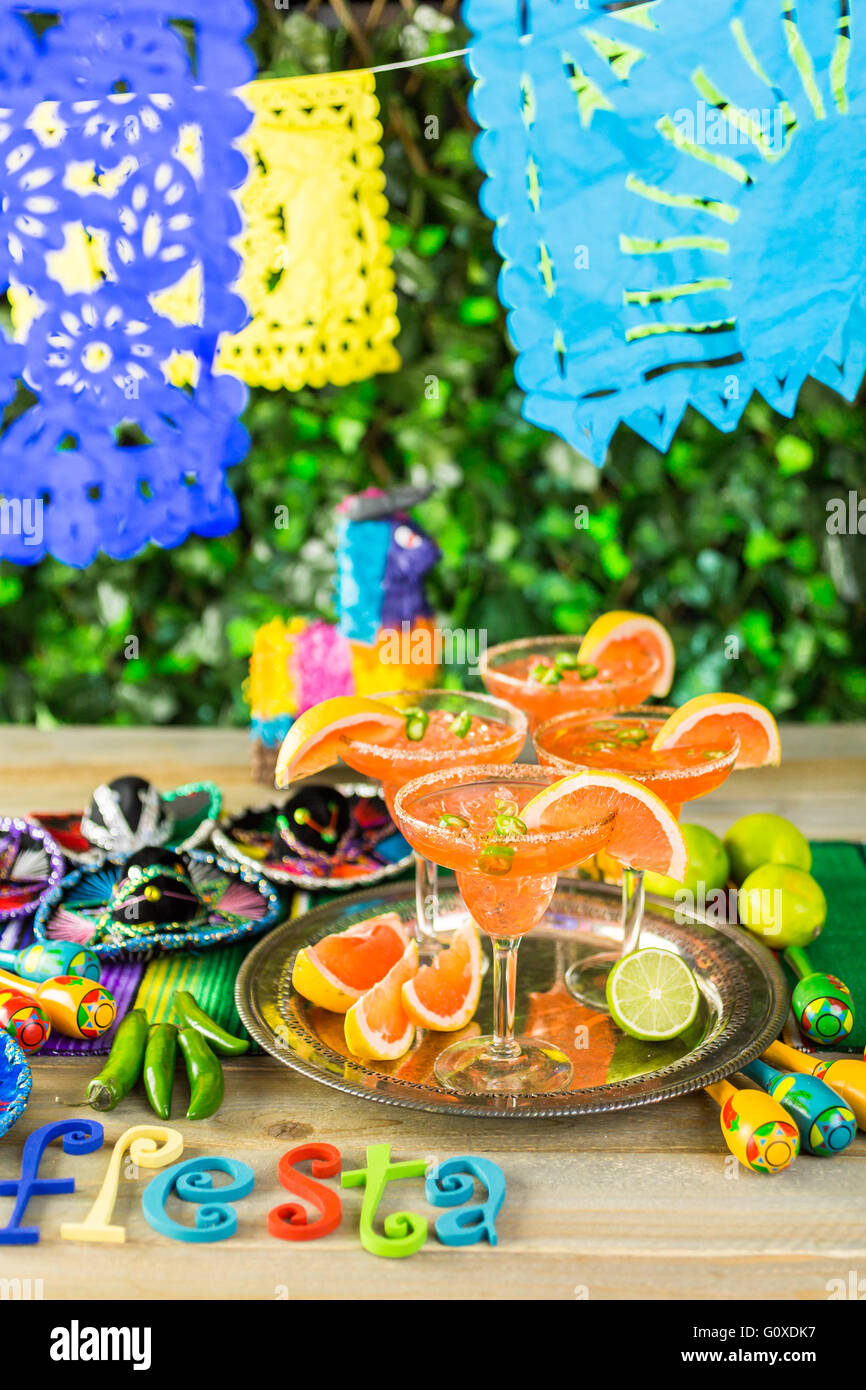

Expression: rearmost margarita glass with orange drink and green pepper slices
xmin=480 ymin=635 xmax=662 ymax=730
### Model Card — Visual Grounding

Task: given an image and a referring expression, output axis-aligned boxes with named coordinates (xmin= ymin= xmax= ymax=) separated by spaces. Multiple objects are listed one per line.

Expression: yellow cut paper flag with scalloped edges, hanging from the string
xmin=220 ymin=72 xmax=400 ymax=391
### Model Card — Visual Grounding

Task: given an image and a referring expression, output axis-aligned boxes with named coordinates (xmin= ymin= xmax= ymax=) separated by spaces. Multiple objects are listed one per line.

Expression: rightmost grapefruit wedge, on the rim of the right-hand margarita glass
xmin=652 ymin=691 xmax=781 ymax=767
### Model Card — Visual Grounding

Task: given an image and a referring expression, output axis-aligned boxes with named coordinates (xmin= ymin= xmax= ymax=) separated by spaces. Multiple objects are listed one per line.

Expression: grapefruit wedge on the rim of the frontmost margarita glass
xmin=520 ymin=771 xmax=688 ymax=883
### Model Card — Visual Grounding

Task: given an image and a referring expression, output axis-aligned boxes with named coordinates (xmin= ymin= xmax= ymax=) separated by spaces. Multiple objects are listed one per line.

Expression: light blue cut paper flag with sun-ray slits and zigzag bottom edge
xmin=464 ymin=0 xmax=866 ymax=464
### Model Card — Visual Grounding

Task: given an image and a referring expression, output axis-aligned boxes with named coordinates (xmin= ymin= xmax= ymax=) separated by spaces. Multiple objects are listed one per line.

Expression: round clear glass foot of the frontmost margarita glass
xmin=434 ymin=1037 xmax=573 ymax=1095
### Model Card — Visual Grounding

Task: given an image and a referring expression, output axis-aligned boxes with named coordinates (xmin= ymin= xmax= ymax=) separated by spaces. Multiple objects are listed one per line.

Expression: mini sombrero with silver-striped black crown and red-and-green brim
xmin=32 ymin=773 xmax=222 ymax=865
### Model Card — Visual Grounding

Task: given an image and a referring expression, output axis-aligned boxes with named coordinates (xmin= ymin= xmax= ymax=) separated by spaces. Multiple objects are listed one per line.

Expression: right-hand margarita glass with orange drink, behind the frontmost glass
xmin=532 ymin=705 xmax=740 ymax=1012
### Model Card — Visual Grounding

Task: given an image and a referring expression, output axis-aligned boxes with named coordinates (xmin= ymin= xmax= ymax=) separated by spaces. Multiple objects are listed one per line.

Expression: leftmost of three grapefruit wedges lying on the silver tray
xmin=292 ymin=912 xmax=409 ymax=1013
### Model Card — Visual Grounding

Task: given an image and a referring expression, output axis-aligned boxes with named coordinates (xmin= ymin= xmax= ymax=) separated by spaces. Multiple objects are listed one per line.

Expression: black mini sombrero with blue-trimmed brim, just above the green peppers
xmin=33 ymin=845 xmax=282 ymax=960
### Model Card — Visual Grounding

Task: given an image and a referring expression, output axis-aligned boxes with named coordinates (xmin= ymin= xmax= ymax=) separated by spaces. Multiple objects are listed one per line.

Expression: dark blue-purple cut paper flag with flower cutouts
xmin=0 ymin=0 xmax=254 ymax=566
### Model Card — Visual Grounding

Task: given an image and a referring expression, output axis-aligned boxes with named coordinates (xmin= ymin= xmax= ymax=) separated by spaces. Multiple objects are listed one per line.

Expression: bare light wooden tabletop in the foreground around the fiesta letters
xmin=0 ymin=1058 xmax=866 ymax=1301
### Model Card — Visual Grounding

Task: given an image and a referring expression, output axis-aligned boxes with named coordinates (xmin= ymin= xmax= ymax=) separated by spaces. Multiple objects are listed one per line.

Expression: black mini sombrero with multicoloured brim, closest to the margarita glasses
xmin=213 ymin=783 xmax=411 ymax=888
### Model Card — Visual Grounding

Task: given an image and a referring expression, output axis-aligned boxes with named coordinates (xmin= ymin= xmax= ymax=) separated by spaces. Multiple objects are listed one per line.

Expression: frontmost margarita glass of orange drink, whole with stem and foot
xmin=395 ymin=763 xmax=614 ymax=1095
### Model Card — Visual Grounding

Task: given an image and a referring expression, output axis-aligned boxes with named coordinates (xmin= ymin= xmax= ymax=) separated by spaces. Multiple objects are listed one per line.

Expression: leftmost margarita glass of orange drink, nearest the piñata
xmin=333 ymin=689 xmax=527 ymax=948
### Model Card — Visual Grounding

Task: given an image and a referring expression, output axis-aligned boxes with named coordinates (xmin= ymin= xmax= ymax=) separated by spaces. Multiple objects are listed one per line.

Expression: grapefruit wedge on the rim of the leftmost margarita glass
xmin=274 ymin=695 xmax=405 ymax=787
